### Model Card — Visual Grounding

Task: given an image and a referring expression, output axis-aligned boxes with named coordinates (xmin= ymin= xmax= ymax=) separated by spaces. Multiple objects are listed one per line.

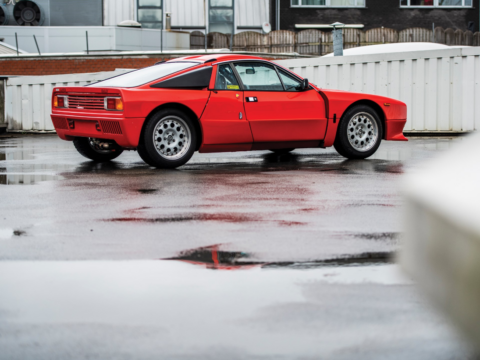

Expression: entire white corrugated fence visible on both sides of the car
xmin=5 ymin=47 xmax=480 ymax=132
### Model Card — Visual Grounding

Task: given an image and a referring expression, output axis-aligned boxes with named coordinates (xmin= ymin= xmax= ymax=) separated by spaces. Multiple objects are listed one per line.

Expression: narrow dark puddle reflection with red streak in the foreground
xmin=166 ymin=245 xmax=395 ymax=270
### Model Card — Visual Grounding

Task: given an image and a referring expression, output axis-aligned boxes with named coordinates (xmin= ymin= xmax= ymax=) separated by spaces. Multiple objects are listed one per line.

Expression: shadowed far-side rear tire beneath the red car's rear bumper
xmin=73 ymin=137 xmax=123 ymax=162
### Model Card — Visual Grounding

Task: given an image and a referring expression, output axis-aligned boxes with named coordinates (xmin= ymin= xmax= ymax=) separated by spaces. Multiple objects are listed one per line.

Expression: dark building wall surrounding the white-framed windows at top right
xmin=270 ymin=0 xmax=480 ymax=31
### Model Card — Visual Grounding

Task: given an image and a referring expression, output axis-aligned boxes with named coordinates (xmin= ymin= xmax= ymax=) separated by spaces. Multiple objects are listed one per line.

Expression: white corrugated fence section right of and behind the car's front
xmin=276 ymin=47 xmax=480 ymax=132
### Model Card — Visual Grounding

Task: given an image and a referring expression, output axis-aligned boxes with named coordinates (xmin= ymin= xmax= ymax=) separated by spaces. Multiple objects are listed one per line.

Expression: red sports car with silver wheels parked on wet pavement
xmin=52 ymin=54 xmax=407 ymax=168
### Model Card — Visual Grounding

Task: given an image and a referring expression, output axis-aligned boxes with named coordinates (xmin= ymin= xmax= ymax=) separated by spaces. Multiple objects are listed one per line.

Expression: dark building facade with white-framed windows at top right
xmin=270 ymin=0 xmax=480 ymax=32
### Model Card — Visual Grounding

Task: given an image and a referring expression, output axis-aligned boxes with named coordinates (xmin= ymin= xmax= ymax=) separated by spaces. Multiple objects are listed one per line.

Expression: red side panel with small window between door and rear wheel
xmin=201 ymin=64 xmax=253 ymax=145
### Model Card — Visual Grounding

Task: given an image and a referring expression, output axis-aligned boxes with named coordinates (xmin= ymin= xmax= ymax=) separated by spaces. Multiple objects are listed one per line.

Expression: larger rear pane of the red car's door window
xmin=235 ymin=62 xmax=283 ymax=91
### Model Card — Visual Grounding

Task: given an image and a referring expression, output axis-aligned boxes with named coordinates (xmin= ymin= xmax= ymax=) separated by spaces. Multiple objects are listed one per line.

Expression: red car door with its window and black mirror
xmin=235 ymin=62 xmax=327 ymax=142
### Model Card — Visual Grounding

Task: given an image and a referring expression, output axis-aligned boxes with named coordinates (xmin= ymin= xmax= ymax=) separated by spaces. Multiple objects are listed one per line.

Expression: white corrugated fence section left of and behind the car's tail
xmin=5 ymin=69 xmax=131 ymax=131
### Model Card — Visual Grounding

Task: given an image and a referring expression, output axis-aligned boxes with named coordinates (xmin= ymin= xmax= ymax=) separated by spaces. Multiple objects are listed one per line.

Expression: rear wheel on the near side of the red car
xmin=137 ymin=109 xmax=197 ymax=169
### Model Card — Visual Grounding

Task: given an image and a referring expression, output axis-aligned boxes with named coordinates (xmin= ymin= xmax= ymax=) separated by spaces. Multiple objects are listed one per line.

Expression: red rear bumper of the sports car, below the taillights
xmin=51 ymin=114 xmax=145 ymax=148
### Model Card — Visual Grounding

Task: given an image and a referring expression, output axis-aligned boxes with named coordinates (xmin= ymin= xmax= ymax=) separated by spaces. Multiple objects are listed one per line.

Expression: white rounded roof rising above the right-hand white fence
xmin=324 ymin=42 xmax=463 ymax=57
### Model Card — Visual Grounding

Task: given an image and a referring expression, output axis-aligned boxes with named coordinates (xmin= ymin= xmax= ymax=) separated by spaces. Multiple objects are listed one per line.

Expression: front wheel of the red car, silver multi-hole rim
xmin=333 ymin=105 xmax=383 ymax=159
